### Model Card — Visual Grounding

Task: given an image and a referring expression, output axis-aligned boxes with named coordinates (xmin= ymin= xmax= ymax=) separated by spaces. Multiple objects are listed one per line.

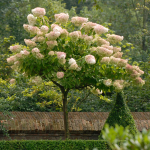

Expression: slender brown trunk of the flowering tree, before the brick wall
xmin=62 ymin=89 xmax=69 ymax=140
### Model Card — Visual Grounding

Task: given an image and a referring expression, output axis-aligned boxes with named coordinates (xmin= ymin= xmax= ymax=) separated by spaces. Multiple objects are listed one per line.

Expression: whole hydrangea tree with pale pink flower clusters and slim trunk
xmin=7 ymin=7 xmax=144 ymax=138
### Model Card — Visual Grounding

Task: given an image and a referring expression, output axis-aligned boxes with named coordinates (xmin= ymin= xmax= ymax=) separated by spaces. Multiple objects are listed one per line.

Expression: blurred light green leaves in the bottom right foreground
xmin=102 ymin=125 xmax=150 ymax=150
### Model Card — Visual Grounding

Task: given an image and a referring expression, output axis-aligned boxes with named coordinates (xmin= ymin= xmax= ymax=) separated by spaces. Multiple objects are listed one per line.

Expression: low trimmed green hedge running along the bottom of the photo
xmin=0 ymin=140 xmax=111 ymax=150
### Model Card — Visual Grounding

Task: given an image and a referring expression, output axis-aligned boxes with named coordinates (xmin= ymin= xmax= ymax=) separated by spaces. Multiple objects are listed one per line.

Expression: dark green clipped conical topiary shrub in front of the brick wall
xmin=99 ymin=92 xmax=137 ymax=139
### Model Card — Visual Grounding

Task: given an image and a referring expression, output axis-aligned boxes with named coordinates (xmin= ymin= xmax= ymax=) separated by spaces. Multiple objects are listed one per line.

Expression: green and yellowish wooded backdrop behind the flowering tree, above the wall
xmin=0 ymin=0 xmax=150 ymax=112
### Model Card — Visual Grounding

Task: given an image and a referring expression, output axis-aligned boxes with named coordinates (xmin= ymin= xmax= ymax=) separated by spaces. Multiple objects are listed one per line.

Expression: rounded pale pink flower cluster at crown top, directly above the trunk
xmin=55 ymin=13 xmax=69 ymax=24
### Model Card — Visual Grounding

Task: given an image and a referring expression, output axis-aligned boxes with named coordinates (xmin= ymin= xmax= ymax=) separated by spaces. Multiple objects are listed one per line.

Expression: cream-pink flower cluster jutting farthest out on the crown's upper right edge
xmin=107 ymin=34 xmax=123 ymax=43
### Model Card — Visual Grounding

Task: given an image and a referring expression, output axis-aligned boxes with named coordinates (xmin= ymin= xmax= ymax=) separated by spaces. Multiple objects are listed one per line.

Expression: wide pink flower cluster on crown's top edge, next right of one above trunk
xmin=71 ymin=17 xmax=88 ymax=26
